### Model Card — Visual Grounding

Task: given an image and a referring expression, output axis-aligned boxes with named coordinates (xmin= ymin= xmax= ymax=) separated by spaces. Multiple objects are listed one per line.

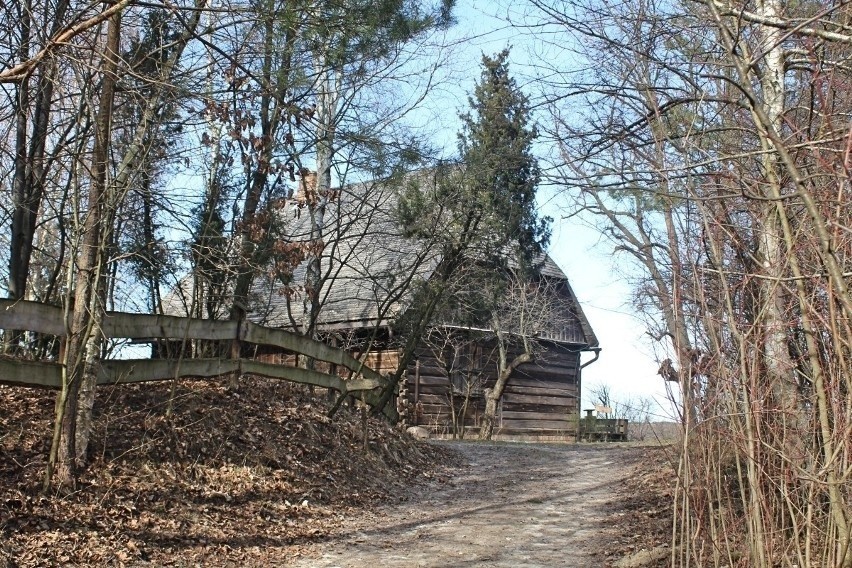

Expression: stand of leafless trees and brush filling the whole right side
xmin=519 ymin=0 xmax=852 ymax=568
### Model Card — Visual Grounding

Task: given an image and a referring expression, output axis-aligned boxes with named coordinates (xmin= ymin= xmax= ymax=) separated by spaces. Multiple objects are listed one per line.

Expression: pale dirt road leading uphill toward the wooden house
xmin=293 ymin=443 xmax=641 ymax=568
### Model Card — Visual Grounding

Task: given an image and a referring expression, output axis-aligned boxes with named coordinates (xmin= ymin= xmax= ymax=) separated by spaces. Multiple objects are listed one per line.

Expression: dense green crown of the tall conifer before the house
xmin=398 ymin=50 xmax=551 ymax=273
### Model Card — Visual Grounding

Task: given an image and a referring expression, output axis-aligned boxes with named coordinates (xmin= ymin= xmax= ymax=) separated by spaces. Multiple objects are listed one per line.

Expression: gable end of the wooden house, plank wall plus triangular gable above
xmin=402 ymin=256 xmax=600 ymax=439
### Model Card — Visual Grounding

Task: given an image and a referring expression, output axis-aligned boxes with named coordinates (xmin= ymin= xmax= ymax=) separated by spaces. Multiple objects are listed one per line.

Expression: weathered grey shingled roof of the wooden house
xmin=248 ymin=172 xmax=598 ymax=349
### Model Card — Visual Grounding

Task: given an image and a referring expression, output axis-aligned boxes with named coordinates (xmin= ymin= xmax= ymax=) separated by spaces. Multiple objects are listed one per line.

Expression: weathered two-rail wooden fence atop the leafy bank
xmin=0 ymin=300 xmax=387 ymax=393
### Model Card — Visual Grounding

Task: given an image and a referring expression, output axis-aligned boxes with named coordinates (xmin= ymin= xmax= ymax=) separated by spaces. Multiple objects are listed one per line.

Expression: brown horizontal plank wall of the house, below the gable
xmin=406 ymin=343 xmax=580 ymax=438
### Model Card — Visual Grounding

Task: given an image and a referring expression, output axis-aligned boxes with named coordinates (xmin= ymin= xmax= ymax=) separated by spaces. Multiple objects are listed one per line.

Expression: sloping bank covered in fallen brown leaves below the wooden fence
xmin=0 ymin=379 xmax=460 ymax=566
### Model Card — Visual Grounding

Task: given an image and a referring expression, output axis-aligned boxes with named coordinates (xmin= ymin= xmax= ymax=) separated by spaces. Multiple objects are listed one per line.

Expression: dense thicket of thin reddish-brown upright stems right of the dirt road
xmin=675 ymin=171 xmax=852 ymax=567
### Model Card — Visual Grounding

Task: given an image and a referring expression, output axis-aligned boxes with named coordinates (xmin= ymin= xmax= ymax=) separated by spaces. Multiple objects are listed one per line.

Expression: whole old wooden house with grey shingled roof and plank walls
xmin=168 ymin=169 xmax=600 ymax=439
